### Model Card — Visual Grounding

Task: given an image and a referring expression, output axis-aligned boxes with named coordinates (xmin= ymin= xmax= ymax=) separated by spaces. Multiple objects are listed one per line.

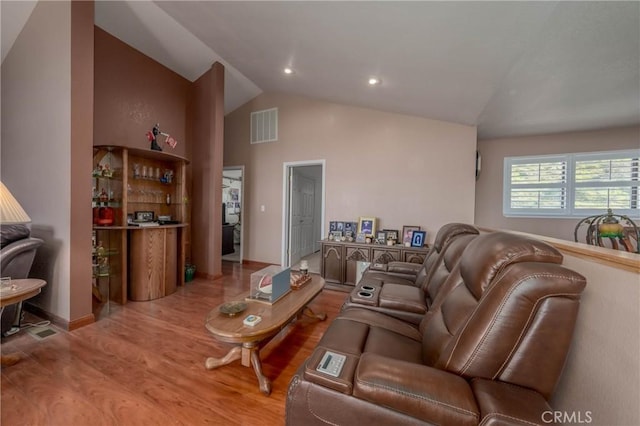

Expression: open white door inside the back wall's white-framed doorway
xmin=289 ymin=168 xmax=315 ymax=265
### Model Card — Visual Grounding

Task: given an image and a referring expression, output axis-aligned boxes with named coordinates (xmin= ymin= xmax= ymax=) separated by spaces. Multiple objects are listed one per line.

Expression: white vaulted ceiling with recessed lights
xmin=2 ymin=1 xmax=640 ymax=139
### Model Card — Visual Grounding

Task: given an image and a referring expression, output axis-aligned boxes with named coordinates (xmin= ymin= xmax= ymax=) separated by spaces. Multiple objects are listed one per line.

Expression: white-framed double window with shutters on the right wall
xmin=503 ymin=150 xmax=640 ymax=217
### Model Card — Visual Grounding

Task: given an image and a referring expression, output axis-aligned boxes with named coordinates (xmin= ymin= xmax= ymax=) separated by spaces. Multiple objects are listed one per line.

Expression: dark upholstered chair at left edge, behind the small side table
xmin=0 ymin=225 xmax=43 ymax=335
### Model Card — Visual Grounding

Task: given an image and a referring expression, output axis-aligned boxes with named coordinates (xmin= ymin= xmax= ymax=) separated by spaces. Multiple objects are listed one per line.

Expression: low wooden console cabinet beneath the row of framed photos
xmin=320 ymin=240 xmax=429 ymax=286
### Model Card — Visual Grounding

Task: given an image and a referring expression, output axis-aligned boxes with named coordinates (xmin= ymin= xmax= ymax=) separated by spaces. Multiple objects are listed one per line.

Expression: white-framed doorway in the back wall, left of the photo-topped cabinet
xmin=281 ymin=160 xmax=325 ymax=273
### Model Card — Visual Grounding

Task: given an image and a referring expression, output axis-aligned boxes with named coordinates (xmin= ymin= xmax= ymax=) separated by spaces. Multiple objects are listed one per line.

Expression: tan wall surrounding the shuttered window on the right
xmin=475 ymin=127 xmax=640 ymax=241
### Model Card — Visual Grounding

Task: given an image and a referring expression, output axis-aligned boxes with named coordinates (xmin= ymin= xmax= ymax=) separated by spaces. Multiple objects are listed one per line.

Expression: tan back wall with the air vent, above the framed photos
xmin=224 ymin=93 xmax=476 ymax=264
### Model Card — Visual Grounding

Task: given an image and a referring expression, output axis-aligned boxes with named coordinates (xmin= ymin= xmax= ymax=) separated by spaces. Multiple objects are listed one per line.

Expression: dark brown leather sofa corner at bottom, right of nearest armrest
xmin=471 ymin=379 xmax=553 ymax=426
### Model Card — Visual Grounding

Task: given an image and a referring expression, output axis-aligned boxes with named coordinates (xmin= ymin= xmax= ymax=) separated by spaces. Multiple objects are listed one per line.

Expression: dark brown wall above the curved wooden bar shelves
xmin=93 ymin=27 xmax=191 ymax=158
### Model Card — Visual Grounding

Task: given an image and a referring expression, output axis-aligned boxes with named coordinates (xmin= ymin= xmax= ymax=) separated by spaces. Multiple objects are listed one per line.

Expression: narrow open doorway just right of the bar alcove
xmin=222 ymin=166 xmax=244 ymax=263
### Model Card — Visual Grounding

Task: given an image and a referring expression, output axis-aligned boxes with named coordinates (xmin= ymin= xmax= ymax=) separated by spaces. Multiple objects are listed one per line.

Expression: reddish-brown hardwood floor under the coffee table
xmin=1 ymin=262 xmax=346 ymax=426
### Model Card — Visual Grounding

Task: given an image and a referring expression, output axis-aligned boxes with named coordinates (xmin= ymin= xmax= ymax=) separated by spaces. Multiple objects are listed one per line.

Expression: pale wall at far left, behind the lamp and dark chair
xmin=0 ymin=2 xmax=72 ymax=320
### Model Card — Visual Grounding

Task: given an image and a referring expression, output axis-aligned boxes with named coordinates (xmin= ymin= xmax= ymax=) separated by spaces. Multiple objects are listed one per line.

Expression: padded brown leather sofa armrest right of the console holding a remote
xmin=353 ymin=353 xmax=480 ymax=426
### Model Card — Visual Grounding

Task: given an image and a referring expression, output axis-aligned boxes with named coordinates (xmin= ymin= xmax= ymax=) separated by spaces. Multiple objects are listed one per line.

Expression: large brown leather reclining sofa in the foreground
xmin=286 ymin=225 xmax=586 ymax=425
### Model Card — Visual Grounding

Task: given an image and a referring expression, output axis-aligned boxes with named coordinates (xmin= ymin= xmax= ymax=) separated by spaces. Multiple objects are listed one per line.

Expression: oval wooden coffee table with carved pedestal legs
xmin=204 ymin=275 xmax=326 ymax=395
